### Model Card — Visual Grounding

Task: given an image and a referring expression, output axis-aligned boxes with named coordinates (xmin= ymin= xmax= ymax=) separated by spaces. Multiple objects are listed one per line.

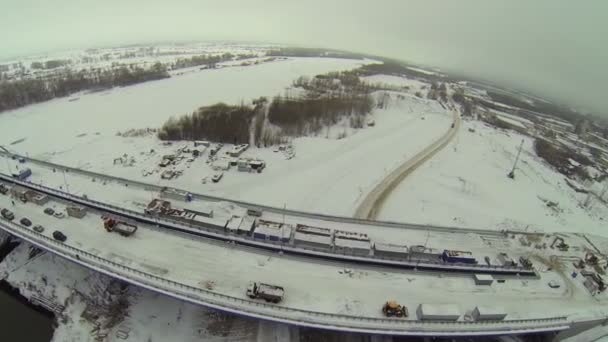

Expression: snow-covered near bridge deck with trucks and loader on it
xmin=0 ymin=172 xmax=605 ymax=335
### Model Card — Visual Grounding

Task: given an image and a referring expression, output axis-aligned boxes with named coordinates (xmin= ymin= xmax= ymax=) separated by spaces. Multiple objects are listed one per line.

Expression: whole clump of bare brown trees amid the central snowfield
xmin=158 ymin=71 xmax=374 ymax=146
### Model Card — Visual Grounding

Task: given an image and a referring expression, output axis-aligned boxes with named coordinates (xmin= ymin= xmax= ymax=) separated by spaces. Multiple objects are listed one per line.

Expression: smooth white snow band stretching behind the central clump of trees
xmin=0 ymin=58 xmax=362 ymax=155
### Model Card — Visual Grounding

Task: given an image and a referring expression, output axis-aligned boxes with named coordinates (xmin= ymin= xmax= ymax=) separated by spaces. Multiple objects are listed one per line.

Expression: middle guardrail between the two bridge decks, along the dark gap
xmin=0 ymin=173 xmax=538 ymax=277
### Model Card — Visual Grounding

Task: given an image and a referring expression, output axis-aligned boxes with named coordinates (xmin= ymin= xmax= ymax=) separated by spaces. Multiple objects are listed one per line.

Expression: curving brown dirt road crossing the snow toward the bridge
xmin=355 ymin=110 xmax=460 ymax=220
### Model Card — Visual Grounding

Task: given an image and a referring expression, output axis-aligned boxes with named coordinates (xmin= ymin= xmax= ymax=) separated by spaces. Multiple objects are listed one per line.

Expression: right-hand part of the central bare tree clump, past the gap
xmin=268 ymin=94 xmax=373 ymax=136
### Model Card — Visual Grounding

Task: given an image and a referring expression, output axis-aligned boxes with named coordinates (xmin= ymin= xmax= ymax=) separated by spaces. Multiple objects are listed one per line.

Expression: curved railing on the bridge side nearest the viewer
xmin=0 ymin=218 xmax=568 ymax=331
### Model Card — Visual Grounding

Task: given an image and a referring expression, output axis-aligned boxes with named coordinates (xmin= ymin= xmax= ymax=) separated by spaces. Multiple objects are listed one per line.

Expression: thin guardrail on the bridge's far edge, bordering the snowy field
xmin=0 ymin=151 xmax=503 ymax=236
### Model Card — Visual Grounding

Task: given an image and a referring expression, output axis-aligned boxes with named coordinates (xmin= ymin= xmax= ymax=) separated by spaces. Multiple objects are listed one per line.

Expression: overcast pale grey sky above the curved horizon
xmin=0 ymin=0 xmax=608 ymax=115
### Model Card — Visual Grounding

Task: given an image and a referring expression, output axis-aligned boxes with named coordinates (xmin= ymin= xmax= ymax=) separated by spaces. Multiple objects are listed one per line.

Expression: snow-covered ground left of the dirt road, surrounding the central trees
xmin=0 ymin=58 xmax=452 ymax=216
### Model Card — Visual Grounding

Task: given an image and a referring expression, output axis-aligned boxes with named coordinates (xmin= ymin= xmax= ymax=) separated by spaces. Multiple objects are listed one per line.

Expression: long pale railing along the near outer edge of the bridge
xmin=0 ymin=218 xmax=569 ymax=335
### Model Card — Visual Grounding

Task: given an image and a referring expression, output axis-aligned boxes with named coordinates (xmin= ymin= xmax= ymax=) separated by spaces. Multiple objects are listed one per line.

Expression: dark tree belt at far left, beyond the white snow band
xmin=0 ymin=63 xmax=169 ymax=112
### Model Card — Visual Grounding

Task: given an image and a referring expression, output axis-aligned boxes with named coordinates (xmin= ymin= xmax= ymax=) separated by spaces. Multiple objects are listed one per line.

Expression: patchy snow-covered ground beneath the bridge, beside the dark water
xmin=0 ymin=242 xmax=290 ymax=342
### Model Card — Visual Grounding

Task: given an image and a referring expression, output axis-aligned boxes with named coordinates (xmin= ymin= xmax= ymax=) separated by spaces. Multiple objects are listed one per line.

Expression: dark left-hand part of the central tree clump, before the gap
xmin=158 ymin=103 xmax=256 ymax=144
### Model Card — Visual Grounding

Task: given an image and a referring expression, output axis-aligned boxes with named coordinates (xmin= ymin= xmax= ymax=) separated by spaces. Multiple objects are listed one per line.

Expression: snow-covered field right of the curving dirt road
xmin=380 ymin=121 xmax=608 ymax=236
